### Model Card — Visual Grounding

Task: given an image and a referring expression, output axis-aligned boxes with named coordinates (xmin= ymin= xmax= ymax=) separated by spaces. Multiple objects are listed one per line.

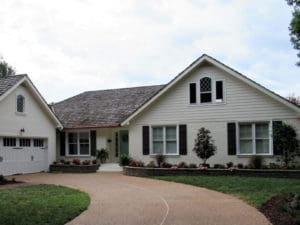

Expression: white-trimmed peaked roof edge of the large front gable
xmin=121 ymin=54 xmax=300 ymax=126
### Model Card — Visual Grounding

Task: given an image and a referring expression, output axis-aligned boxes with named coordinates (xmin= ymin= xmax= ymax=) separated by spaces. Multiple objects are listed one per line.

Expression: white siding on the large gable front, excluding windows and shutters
xmin=129 ymin=66 xmax=300 ymax=164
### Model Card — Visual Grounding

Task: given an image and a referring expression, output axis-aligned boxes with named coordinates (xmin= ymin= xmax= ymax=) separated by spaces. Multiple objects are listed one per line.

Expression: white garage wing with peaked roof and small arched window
xmin=0 ymin=75 xmax=62 ymax=175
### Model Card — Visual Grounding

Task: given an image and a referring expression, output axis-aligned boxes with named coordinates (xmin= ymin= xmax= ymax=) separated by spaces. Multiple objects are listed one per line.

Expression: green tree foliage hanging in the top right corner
xmin=286 ymin=0 xmax=300 ymax=66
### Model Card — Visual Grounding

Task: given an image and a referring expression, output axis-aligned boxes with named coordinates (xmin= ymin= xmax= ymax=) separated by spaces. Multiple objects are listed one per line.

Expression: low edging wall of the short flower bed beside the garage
xmin=50 ymin=164 xmax=100 ymax=173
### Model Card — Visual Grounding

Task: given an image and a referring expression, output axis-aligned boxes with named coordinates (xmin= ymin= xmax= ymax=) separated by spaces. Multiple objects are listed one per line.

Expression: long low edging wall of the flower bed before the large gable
xmin=123 ymin=166 xmax=300 ymax=179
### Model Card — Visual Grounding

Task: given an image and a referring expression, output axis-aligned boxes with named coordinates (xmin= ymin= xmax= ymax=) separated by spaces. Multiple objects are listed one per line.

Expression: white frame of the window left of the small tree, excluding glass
xmin=150 ymin=124 xmax=179 ymax=156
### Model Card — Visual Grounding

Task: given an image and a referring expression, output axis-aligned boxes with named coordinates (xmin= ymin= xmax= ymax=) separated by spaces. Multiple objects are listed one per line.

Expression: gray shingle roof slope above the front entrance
xmin=53 ymin=85 xmax=164 ymax=128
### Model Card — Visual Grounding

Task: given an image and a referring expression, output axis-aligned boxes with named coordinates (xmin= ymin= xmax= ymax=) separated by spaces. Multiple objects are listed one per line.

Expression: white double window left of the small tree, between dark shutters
xmin=152 ymin=126 xmax=179 ymax=155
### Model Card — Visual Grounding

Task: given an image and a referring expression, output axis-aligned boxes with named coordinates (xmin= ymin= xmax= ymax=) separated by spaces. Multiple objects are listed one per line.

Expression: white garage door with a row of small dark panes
xmin=0 ymin=137 xmax=48 ymax=175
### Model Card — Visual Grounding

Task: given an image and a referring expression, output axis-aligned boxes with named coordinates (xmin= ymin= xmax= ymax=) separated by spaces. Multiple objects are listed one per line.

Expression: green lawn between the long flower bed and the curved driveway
xmin=154 ymin=176 xmax=300 ymax=208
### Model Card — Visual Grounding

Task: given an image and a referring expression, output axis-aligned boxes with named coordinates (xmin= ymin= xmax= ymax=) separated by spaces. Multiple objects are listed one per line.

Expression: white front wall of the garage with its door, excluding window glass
xmin=0 ymin=85 xmax=56 ymax=175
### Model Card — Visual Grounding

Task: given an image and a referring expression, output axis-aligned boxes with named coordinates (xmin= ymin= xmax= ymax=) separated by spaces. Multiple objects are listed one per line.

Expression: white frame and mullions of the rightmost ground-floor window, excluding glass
xmin=236 ymin=120 xmax=273 ymax=156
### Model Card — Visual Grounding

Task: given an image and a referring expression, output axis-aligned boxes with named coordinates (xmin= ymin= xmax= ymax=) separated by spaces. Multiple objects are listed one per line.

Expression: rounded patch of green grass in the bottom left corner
xmin=0 ymin=185 xmax=90 ymax=225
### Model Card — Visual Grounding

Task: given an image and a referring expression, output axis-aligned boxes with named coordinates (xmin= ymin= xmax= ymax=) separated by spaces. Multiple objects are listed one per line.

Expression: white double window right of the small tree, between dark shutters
xmin=239 ymin=122 xmax=271 ymax=155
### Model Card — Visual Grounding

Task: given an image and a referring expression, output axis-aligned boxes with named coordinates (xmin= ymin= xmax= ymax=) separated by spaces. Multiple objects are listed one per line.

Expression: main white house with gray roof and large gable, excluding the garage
xmin=53 ymin=55 xmax=300 ymax=164
